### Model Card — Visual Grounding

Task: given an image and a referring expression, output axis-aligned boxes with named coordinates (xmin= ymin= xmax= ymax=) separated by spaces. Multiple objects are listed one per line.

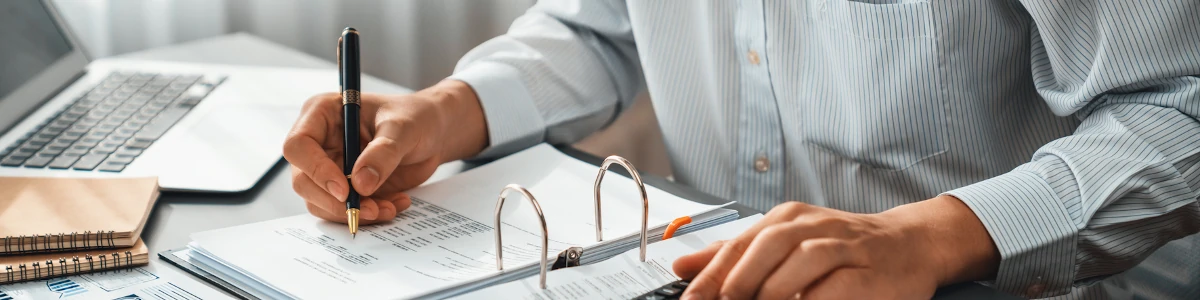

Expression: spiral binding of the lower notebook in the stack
xmin=2 ymin=251 xmax=133 ymax=284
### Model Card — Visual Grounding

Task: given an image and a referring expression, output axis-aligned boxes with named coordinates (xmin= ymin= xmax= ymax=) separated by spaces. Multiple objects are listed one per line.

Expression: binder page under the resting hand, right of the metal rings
xmin=455 ymin=215 xmax=762 ymax=300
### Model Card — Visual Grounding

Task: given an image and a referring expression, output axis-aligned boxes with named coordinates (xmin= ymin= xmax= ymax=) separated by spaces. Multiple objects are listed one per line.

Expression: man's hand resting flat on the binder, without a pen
xmin=674 ymin=196 xmax=1000 ymax=299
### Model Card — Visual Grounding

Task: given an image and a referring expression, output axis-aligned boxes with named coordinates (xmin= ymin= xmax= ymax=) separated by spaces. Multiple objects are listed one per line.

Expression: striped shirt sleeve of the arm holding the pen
xmin=449 ymin=0 xmax=644 ymax=158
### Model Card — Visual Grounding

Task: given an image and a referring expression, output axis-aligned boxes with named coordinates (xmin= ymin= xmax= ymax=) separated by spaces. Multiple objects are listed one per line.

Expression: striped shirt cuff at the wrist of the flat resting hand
xmin=946 ymin=168 xmax=1078 ymax=298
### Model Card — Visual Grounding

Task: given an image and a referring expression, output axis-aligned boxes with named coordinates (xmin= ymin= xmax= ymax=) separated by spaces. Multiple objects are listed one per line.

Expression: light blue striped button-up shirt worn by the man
xmin=451 ymin=0 xmax=1200 ymax=299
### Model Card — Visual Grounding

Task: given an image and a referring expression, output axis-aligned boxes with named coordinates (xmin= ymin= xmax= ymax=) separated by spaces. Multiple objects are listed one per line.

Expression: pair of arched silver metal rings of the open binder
xmin=494 ymin=155 xmax=650 ymax=289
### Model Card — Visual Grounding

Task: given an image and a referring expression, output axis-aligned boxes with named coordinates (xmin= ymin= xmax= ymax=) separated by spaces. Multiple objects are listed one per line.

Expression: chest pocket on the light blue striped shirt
xmin=804 ymin=0 xmax=948 ymax=170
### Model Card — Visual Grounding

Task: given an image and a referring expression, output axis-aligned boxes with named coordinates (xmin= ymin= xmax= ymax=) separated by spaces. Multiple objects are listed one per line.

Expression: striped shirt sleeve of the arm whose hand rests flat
xmin=947 ymin=0 xmax=1200 ymax=298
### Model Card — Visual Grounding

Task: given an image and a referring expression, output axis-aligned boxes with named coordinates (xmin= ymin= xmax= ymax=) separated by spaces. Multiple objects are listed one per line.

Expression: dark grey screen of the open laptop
xmin=0 ymin=0 xmax=72 ymax=132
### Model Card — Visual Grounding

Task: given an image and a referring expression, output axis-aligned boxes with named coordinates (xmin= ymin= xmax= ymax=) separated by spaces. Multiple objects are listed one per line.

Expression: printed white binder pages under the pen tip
xmin=190 ymin=145 xmax=720 ymax=299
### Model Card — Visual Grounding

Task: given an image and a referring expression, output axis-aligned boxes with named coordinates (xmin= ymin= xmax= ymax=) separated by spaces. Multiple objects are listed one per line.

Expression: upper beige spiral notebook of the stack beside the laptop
xmin=0 ymin=176 xmax=158 ymax=256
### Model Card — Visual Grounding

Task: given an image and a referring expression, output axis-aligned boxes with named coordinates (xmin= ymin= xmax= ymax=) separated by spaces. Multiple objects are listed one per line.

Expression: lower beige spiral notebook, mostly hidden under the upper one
xmin=0 ymin=239 xmax=150 ymax=284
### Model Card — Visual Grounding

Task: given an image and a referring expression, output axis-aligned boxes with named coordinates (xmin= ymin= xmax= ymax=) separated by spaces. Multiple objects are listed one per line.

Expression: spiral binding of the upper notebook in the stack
xmin=0 ymin=230 xmax=116 ymax=254
